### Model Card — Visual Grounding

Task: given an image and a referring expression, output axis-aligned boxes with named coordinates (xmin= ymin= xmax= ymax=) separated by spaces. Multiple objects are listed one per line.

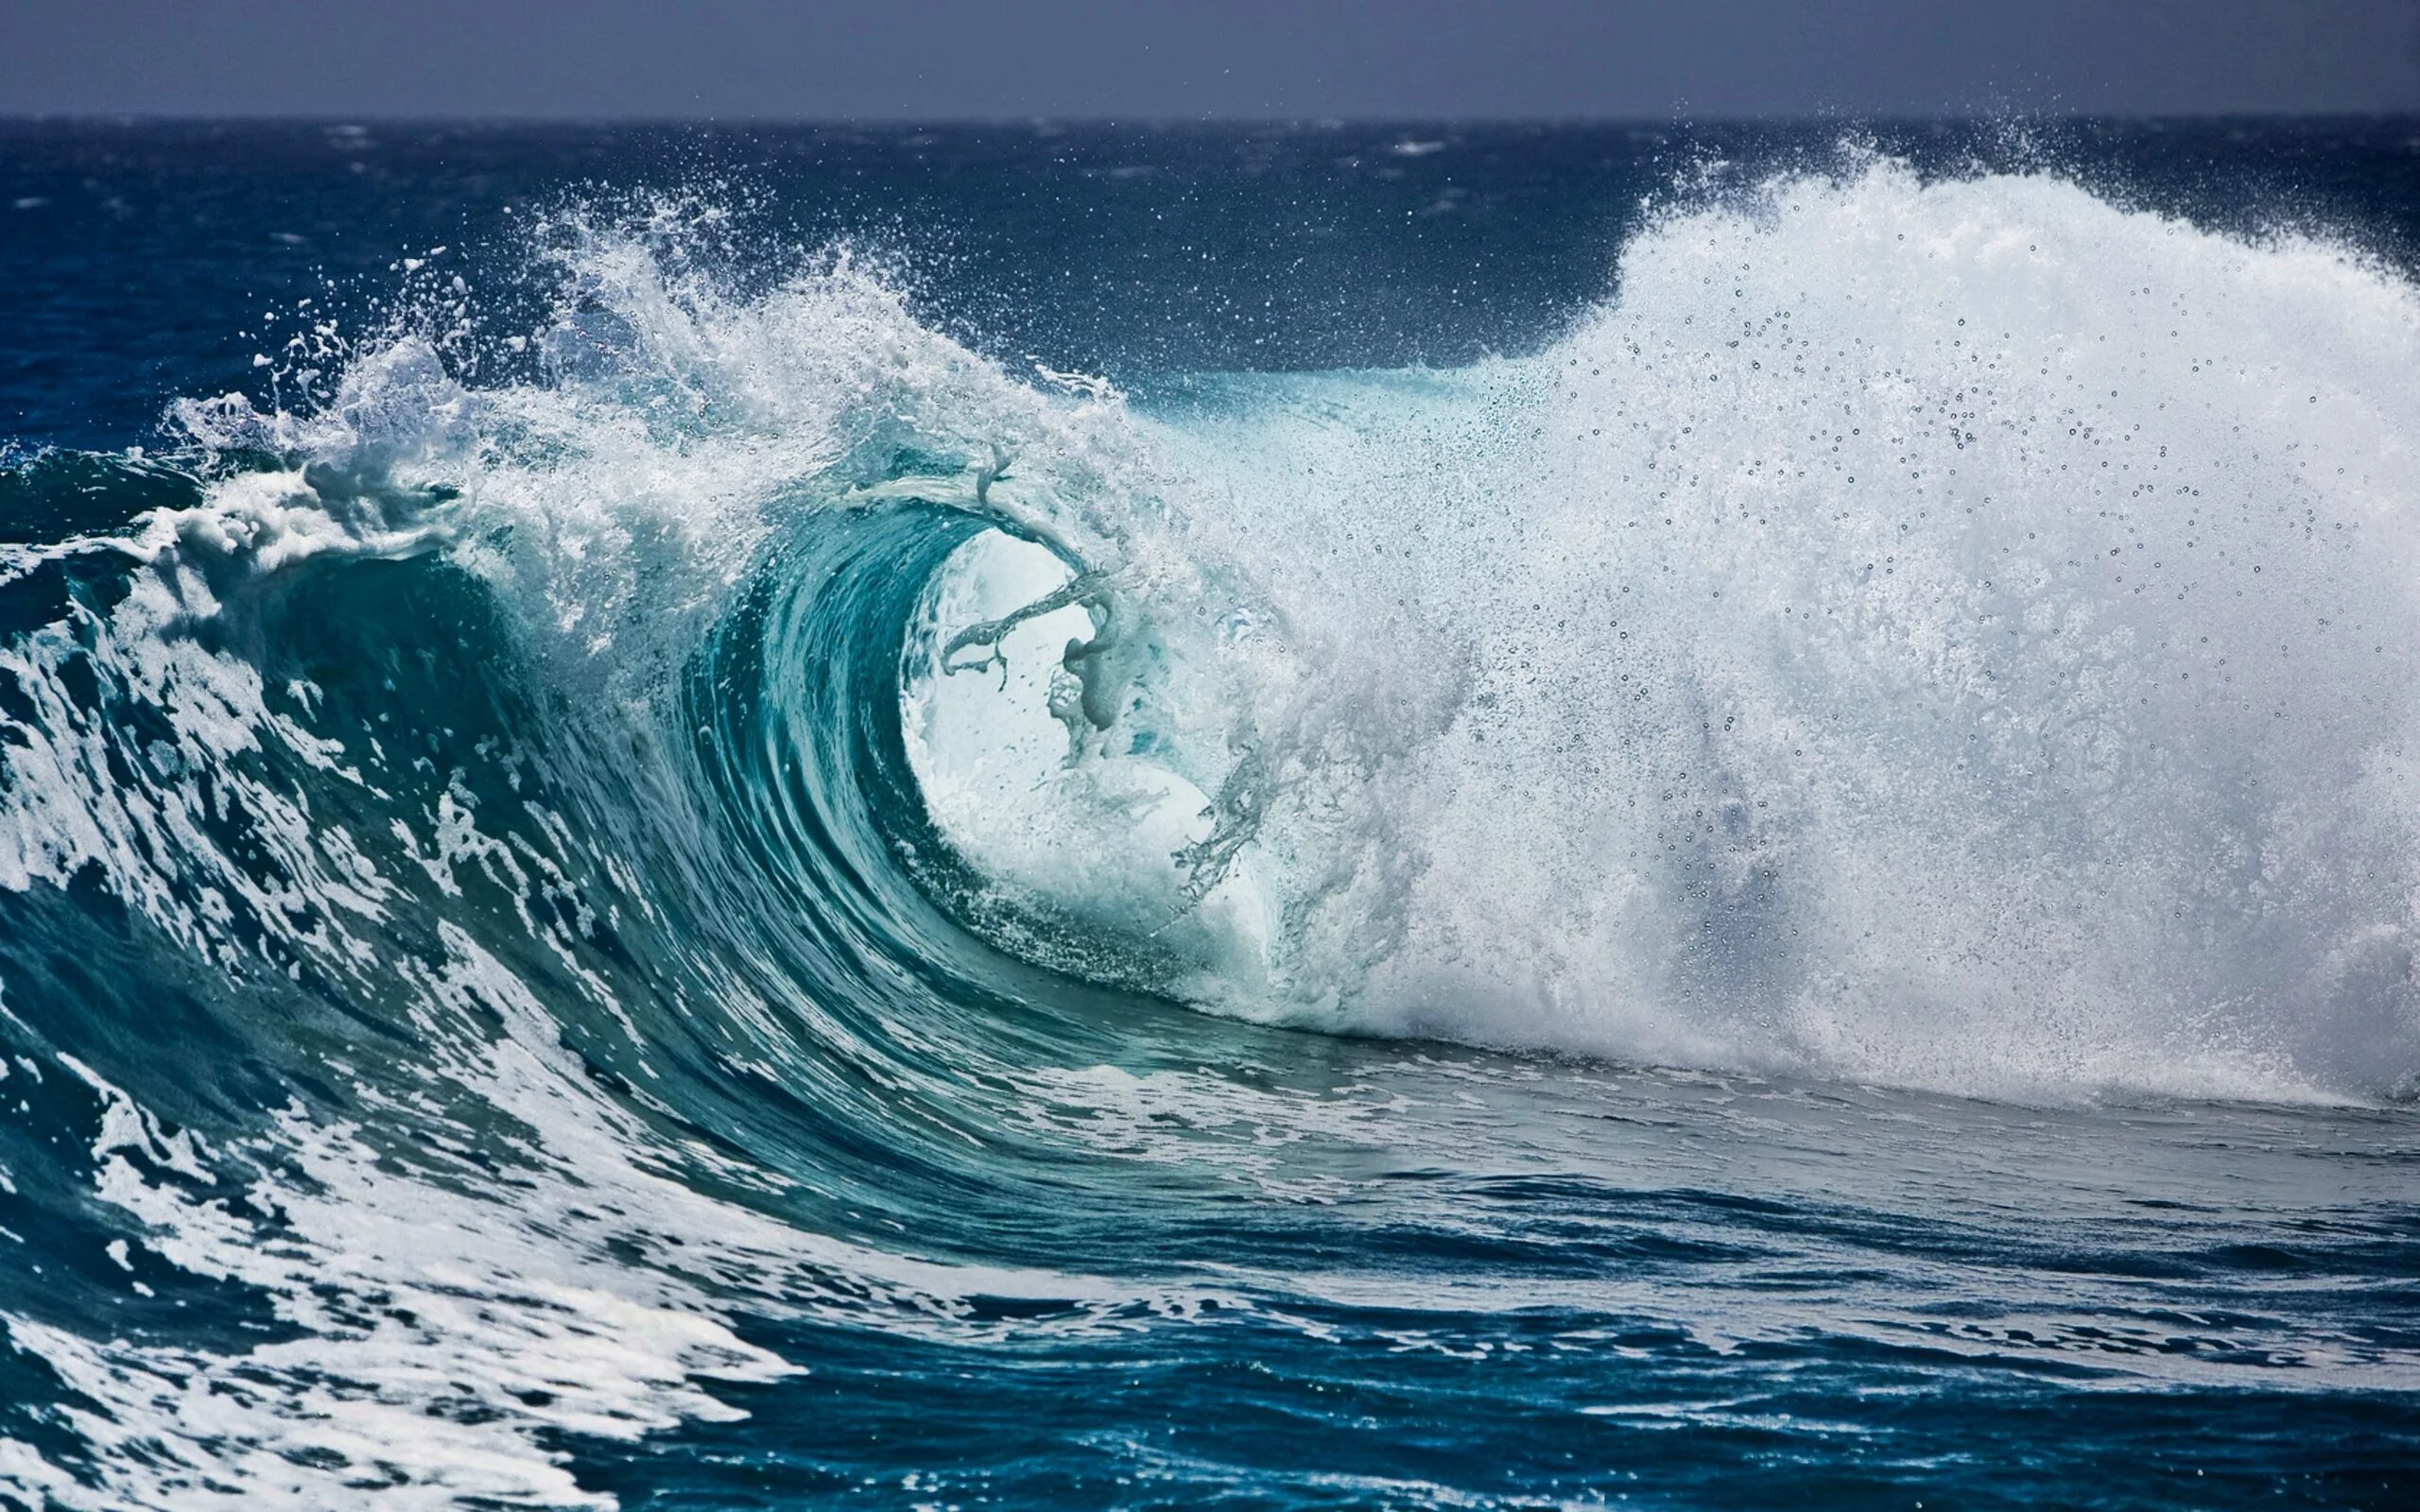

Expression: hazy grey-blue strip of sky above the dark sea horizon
xmin=0 ymin=0 xmax=2420 ymax=121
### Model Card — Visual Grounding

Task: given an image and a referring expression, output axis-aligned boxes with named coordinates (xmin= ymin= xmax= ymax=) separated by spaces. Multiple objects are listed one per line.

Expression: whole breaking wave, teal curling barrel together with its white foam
xmin=0 ymin=135 xmax=2420 ymax=1507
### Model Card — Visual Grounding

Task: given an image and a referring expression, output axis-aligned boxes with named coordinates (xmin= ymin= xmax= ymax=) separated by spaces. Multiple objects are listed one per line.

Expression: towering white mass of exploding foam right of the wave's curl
xmin=905 ymin=163 xmax=2420 ymax=1096
